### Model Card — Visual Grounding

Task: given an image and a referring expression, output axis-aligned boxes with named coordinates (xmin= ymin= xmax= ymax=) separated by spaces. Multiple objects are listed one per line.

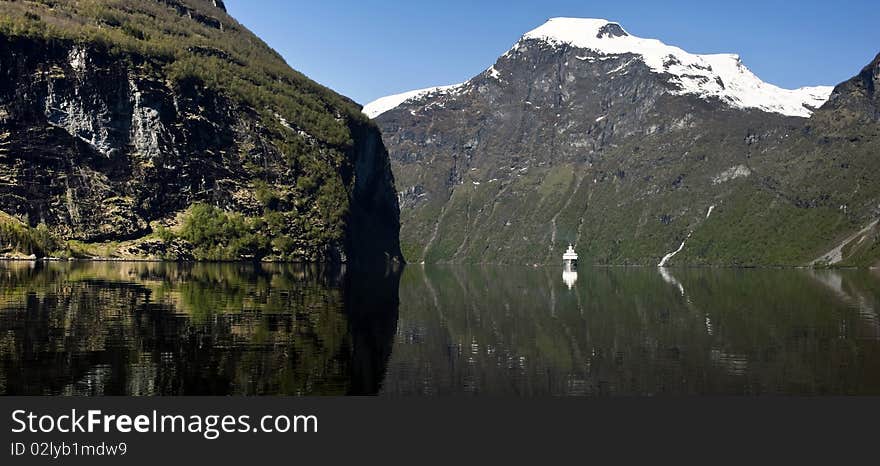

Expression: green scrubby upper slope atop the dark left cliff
xmin=0 ymin=0 xmax=367 ymax=146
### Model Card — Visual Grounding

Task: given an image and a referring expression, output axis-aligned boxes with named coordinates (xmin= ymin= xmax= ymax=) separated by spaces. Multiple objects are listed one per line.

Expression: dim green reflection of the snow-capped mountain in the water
xmin=382 ymin=267 xmax=880 ymax=396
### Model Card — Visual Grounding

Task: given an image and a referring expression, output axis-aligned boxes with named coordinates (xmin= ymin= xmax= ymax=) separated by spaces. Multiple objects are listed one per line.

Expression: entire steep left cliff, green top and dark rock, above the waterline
xmin=0 ymin=0 xmax=400 ymax=261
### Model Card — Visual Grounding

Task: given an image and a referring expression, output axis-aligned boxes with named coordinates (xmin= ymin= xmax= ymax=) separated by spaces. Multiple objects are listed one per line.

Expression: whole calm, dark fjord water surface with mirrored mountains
xmin=0 ymin=262 xmax=880 ymax=396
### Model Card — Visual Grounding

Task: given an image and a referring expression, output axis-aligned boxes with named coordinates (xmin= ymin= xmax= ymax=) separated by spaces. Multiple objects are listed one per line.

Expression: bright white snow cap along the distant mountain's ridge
xmin=363 ymin=18 xmax=833 ymax=118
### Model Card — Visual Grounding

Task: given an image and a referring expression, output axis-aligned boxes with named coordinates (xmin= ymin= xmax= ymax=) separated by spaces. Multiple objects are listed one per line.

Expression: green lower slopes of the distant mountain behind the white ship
xmin=395 ymin=109 xmax=880 ymax=266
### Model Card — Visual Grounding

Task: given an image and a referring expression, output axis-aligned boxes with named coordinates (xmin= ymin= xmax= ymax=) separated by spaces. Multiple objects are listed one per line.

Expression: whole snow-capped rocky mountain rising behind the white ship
xmin=365 ymin=20 xmax=876 ymax=265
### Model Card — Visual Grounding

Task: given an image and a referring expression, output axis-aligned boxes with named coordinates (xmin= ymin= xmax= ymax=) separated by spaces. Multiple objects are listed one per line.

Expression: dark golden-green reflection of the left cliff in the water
xmin=0 ymin=262 xmax=397 ymax=395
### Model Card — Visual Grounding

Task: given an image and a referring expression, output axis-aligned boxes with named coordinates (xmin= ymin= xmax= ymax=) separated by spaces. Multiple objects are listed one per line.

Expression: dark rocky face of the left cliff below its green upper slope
xmin=0 ymin=1 xmax=400 ymax=261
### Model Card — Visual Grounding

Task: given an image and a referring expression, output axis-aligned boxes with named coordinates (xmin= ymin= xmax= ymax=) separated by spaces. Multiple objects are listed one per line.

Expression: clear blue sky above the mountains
xmin=226 ymin=0 xmax=880 ymax=104
